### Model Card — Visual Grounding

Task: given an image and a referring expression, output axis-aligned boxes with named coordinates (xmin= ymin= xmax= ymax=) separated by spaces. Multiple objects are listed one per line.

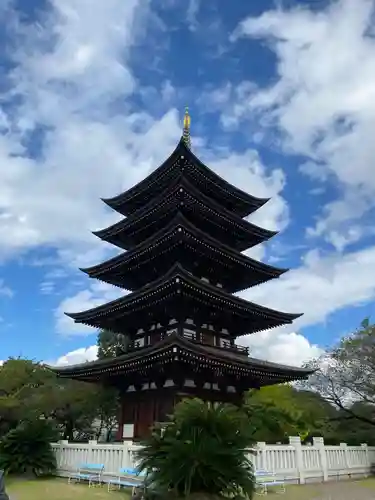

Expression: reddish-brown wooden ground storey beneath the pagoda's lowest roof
xmin=116 ymin=387 xmax=243 ymax=441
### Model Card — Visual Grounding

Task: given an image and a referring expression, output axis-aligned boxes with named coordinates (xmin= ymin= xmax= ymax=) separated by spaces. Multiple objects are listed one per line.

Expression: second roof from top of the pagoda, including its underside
xmin=93 ymin=178 xmax=277 ymax=251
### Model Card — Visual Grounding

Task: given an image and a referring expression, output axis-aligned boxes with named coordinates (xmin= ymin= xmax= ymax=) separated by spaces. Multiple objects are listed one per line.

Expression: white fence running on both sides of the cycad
xmin=52 ymin=437 xmax=375 ymax=484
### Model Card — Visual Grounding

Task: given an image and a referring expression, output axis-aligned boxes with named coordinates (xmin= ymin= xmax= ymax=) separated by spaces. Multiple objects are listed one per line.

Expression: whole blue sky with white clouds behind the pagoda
xmin=0 ymin=0 xmax=375 ymax=364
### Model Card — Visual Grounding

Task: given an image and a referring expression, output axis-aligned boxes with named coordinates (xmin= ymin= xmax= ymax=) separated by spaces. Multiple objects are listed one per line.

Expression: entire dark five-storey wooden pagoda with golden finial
xmin=55 ymin=110 xmax=311 ymax=440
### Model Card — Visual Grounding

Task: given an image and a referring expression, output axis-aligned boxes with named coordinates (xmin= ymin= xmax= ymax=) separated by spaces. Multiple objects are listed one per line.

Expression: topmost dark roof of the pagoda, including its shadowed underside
xmin=103 ymin=137 xmax=269 ymax=217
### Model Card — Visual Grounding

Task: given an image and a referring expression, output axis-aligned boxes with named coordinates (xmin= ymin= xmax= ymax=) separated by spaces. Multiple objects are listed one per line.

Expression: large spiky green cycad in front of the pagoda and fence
xmin=138 ymin=399 xmax=254 ymax=498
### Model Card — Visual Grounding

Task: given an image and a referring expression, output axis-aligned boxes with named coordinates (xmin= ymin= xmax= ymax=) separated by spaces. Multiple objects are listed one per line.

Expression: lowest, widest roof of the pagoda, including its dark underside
xmin=50 ymin=332 xmax=314 ymax=388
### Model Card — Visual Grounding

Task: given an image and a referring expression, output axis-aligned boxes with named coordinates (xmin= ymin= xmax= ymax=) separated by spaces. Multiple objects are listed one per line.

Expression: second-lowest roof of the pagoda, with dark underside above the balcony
xmin=65 ymin=264 xmax=301 ymax=335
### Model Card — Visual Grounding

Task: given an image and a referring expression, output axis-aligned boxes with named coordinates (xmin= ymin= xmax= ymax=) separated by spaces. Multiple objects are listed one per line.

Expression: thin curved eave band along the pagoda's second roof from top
xmin=93 ymin=179 xmax=277 ymax=245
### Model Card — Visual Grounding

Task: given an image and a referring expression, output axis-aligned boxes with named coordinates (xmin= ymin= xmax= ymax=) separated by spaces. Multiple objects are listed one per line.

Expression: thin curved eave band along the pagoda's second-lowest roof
xmin=65 ymin=264 xmax=302 ymax=331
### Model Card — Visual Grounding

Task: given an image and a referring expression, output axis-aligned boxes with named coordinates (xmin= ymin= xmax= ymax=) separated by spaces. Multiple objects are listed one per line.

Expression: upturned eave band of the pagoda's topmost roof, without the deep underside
xmin=101 ymin=137 xmax=270 ymax=217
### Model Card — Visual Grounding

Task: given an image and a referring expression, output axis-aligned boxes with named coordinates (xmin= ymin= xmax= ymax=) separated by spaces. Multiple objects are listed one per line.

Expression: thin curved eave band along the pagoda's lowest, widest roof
xmin=48 ymin=334 xmax=315 ymax=380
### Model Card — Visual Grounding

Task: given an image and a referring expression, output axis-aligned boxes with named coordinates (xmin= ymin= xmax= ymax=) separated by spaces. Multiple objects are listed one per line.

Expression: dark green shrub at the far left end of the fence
xmin=0 ymin=420 xmax=56 ymax=476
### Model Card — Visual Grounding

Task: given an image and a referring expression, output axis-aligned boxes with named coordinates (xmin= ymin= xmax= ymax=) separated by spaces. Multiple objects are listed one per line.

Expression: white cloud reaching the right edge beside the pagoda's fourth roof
xmin=241 ymin=247 xmax=375 ymax=330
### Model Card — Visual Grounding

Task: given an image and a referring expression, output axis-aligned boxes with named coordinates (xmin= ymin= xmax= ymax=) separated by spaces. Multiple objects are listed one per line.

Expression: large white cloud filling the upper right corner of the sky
xmin=232 ymin=0 xmax=375 ymax=250
